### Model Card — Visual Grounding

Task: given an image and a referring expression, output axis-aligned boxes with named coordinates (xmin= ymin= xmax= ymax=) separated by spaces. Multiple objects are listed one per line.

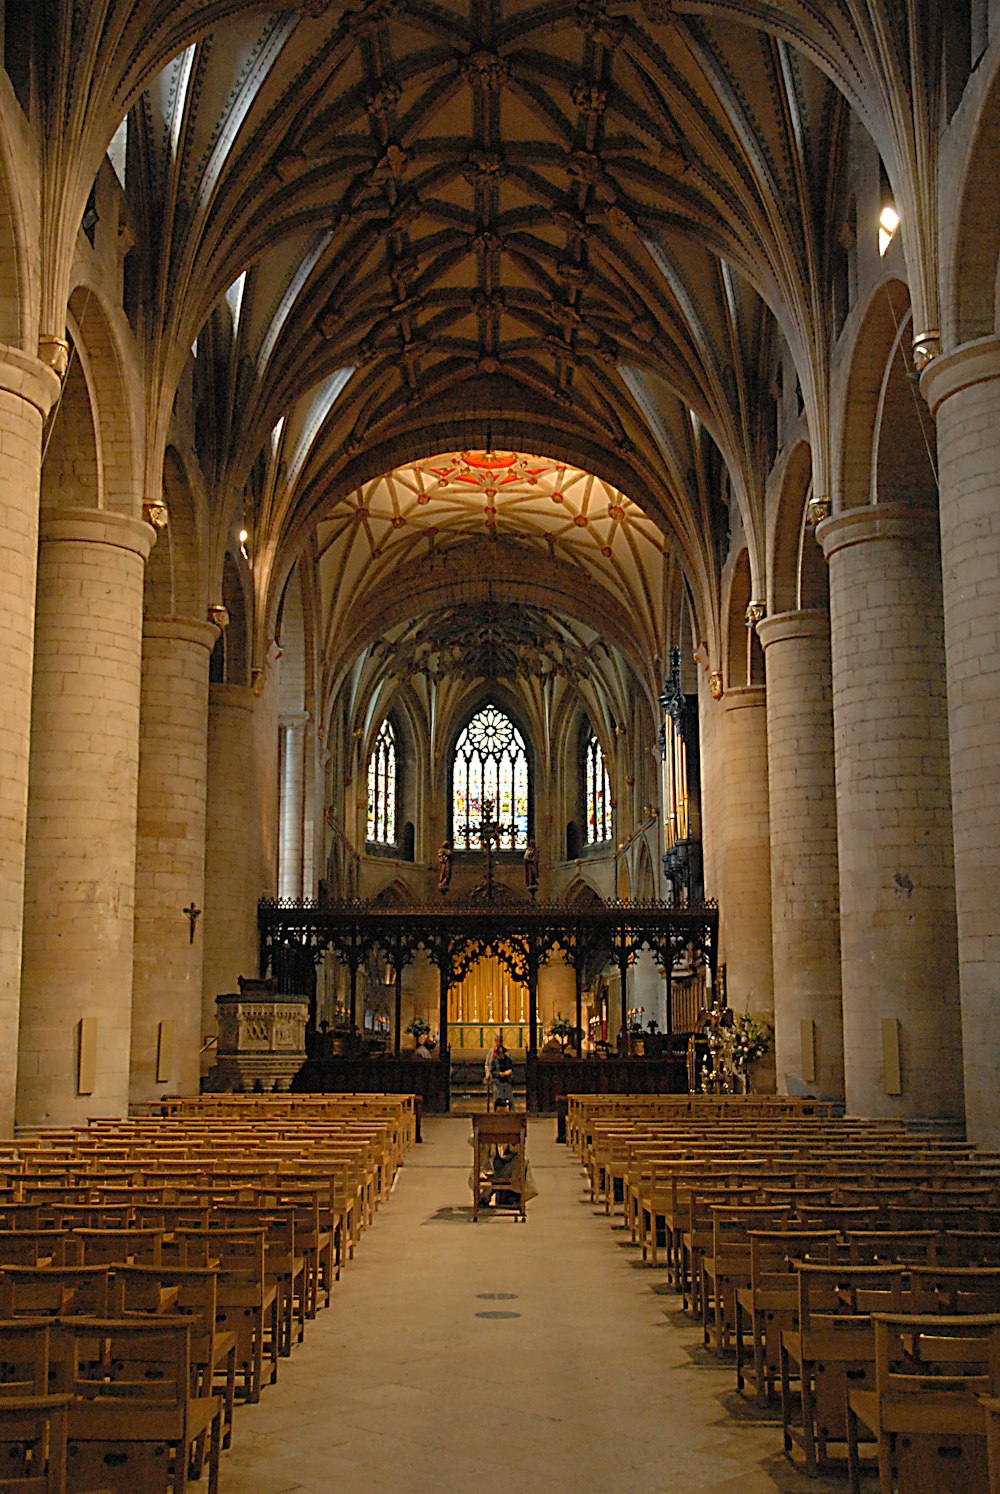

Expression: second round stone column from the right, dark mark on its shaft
xmin=816 ymin=505 xmax=963 ymax=1118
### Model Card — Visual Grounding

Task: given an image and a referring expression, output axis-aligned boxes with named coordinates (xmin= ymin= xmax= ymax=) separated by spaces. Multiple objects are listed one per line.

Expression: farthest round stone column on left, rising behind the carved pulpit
xmin=202 ymin=684 xmax=278 ymax=1068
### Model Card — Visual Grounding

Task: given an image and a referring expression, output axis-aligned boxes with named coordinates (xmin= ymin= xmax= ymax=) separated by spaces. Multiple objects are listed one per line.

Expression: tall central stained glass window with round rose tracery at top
xmin=451 ymin=705 xmax=528 ymax=850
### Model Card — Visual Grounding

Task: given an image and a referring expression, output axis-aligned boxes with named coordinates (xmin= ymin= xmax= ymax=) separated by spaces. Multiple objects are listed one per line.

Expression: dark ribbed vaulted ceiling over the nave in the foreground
xmin=39 ymin=0 xmax=931 ymax=669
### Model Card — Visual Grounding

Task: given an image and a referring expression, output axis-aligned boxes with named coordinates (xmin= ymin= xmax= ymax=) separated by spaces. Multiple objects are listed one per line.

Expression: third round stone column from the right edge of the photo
xmin=756 ymin=611 xmax=843 ymax=1100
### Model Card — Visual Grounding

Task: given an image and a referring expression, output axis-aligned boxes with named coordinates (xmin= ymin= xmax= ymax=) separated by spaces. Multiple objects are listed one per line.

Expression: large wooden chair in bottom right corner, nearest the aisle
xmin=848 ymin=1313 xmax=1000 ymax=1494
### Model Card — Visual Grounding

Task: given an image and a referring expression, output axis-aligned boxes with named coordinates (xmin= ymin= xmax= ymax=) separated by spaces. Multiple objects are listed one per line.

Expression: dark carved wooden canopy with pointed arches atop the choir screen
xmin=257 ymin=898 xmax=719 ymax=1053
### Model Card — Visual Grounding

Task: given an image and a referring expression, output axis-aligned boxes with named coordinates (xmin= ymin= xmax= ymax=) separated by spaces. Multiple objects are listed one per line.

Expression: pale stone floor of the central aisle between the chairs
xmin=221 ymin=1119 xmax=846 ymax=1494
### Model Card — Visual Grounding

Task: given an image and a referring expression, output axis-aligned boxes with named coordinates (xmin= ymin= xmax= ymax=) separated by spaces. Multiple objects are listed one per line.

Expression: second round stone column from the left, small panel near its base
xmin=18 ymin=509 xmax=154 ymax=1125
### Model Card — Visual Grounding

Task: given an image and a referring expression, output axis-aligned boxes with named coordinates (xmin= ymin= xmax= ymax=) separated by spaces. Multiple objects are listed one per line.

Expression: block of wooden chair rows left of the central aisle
xmin=0 ymin=1095 xmax=416 ymax=1494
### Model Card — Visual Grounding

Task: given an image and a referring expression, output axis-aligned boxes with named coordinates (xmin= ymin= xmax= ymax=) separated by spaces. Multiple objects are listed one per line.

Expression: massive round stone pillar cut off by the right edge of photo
xmin=922 ymin=338 xmax=1000 ymax=1147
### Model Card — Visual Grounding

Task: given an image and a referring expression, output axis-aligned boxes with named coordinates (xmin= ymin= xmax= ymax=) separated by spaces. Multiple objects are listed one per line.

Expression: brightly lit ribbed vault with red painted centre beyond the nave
xmin=315 ymin=451 xmax=667 ymax=677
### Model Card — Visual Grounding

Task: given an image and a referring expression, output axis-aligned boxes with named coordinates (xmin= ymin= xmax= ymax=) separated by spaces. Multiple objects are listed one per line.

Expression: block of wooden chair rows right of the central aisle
xmin=568 ymin=1095 xmax=1000 ymax=1494
